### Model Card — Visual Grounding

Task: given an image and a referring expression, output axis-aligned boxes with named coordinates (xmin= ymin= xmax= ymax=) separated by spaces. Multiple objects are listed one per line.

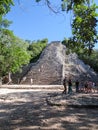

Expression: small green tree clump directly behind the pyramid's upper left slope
xmin=28 ymin=39 xmax=48 ymax=62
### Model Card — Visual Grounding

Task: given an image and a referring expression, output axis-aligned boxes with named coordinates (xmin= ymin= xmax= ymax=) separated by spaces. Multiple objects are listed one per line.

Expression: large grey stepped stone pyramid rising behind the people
xmin=11 ymin=42 xmax=98 ymax=85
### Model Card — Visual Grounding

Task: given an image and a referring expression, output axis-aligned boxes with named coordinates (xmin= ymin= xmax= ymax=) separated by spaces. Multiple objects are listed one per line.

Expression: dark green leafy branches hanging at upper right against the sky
xmin=72 ymin=4 xmax=98 ymax=55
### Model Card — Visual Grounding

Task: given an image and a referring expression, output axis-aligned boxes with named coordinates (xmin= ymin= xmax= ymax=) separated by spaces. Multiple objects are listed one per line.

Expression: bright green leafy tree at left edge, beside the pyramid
xmin=0 ymin=29 xmax=30 ymax=76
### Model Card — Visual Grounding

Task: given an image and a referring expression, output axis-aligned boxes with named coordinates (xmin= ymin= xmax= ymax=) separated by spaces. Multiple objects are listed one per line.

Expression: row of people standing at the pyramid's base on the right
xmin=62 ymin=76 xmax=98 ymax=94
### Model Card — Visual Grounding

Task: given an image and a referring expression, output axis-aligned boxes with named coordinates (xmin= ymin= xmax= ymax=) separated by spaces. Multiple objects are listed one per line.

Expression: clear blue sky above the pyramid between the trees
xmin=6 ymin=0 xmax=98 ymax=48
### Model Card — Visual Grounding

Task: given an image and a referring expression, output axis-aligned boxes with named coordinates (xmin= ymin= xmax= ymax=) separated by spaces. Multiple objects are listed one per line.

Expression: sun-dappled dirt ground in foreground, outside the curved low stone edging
xmin=0 ymin=89 xmax=98 ymax=130
